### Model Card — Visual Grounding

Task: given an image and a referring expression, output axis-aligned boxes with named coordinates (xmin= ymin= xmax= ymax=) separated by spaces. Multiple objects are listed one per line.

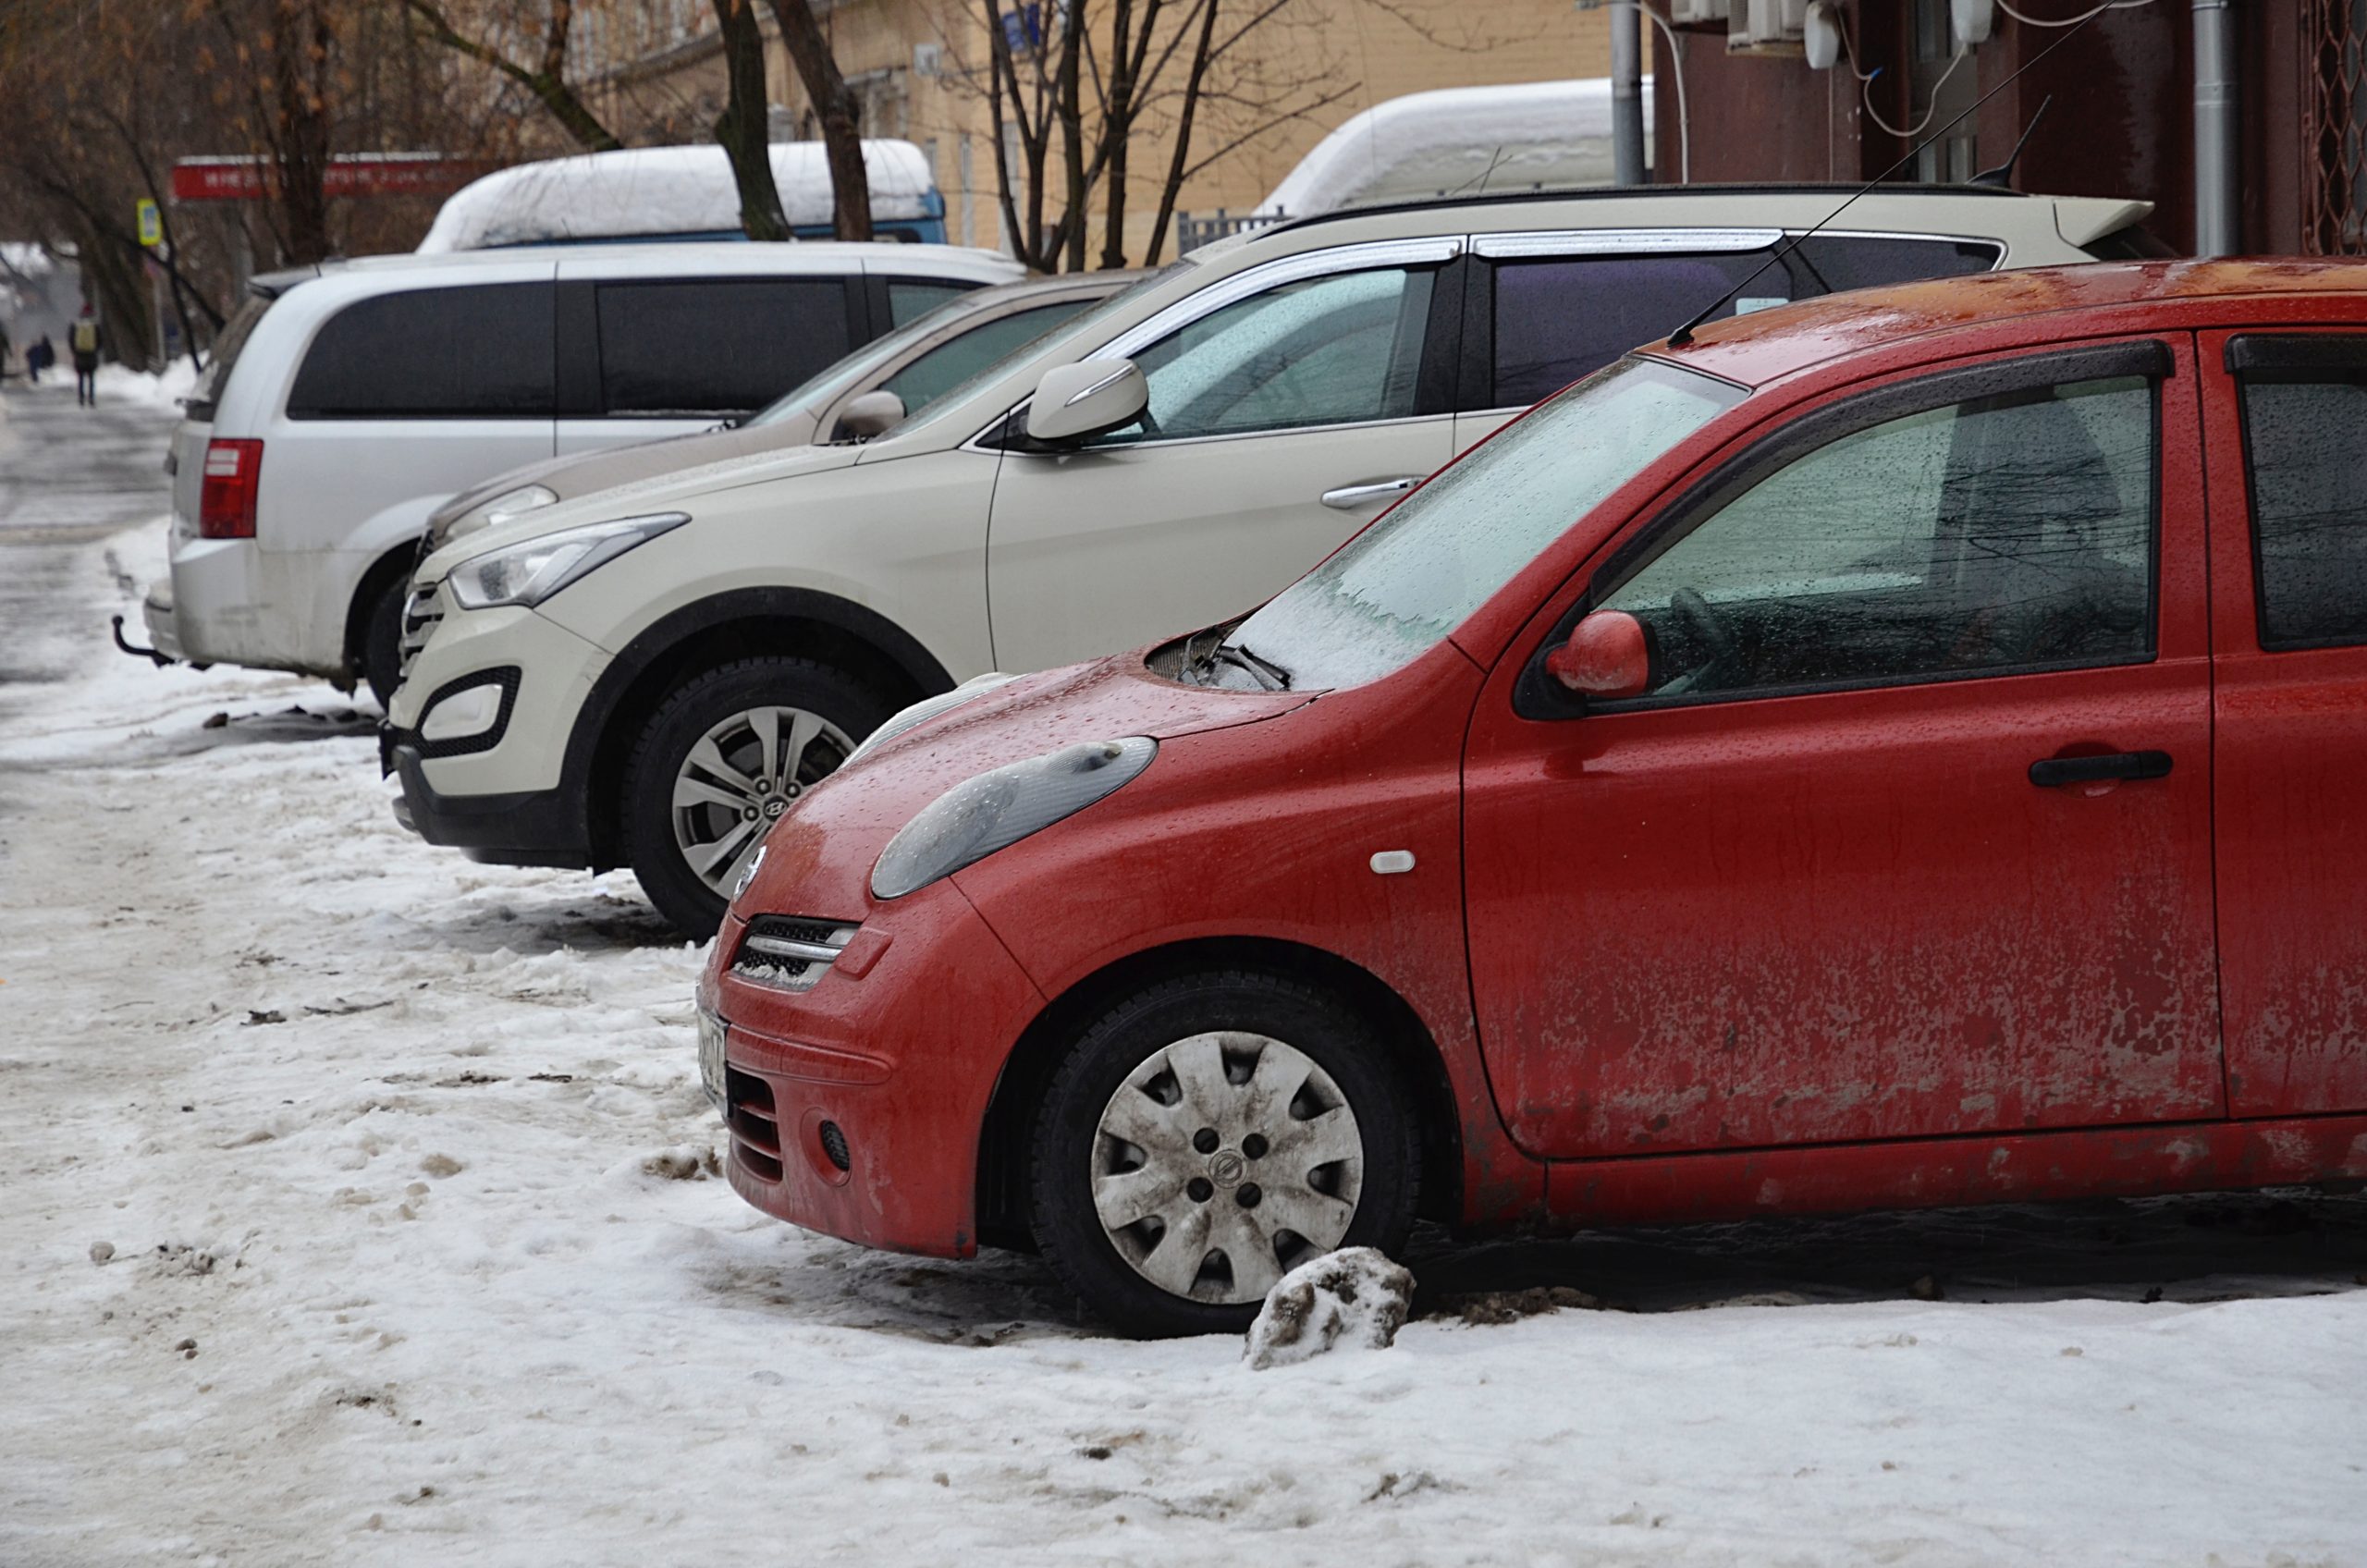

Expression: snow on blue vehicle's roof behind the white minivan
xmin=419 ymin=140 xmax=935 ymax=256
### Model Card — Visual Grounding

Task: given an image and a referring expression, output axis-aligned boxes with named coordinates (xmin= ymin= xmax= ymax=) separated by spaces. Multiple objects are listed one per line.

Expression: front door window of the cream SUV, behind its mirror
xmin=1103 ymin=267 xmax=1432 ymax=443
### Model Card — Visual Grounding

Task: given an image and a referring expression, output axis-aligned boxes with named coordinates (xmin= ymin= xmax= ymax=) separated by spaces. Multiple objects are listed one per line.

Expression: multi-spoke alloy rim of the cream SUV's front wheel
xmin=675 ymin=708 xmax=854 ymax=895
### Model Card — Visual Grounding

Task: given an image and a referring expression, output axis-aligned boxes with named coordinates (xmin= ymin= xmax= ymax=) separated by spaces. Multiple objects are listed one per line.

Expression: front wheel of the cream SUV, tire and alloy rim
xmin=625 ymin=658 xmax=895 ymax=938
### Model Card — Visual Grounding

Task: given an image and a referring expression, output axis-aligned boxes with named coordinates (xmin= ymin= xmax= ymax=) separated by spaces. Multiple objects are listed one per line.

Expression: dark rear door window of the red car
xmin=2244 ymin=376 xmax=2367 ymax=649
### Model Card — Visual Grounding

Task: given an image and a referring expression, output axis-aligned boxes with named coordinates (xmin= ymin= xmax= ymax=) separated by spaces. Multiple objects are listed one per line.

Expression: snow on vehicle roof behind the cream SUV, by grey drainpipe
xmin=1257 ymin=76 xmax=1652 ymax=218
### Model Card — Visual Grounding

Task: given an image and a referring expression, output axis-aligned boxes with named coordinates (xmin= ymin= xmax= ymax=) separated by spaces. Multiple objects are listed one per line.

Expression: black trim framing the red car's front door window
xmin=1513 ymin=337 xmax=2177 ymax=722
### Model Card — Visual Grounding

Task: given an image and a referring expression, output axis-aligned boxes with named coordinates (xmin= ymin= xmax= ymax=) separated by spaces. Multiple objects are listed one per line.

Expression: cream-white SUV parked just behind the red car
xmin=384 ymin=187 xmax=2147 ymax=933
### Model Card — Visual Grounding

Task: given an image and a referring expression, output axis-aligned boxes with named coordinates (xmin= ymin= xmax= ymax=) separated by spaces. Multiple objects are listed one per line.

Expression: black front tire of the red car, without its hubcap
xmin=1027 ymin=971 xmax=1420 ymax=1338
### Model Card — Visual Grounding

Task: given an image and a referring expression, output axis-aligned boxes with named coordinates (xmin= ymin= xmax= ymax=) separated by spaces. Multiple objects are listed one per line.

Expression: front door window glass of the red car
xmin=1600 ymin=376 xmax=2156 ymax=699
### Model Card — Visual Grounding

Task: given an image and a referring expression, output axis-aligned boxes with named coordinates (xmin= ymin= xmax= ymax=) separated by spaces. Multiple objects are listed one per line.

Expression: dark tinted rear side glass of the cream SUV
xmin=1491 ymin=235 xmax=2000 ymax=408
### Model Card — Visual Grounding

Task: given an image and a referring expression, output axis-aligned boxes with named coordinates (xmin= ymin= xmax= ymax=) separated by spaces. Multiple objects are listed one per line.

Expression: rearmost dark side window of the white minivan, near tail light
xmin=288 ymin=282 xmax=554 ymax=419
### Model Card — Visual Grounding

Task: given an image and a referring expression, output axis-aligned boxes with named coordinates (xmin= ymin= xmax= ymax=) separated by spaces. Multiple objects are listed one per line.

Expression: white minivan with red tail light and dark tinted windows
xmin=147 ymin=244 xmax=1023 ymax=701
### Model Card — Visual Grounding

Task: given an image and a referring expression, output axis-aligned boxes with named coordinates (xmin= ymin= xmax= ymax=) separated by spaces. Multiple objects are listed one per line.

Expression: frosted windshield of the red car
xmin=1226 ymin=358 xmax=1745 ymax=690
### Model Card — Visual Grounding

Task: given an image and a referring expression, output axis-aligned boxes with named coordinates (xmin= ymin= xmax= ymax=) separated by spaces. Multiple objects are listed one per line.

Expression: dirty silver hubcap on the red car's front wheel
xmin=1091 ymin=1033 xmax=1364 ymax=1305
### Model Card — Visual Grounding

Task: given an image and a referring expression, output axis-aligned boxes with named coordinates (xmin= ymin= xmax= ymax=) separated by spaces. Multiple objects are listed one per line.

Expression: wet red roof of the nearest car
xmin=1645 ymin=256 xmax=2367 ymax=386
